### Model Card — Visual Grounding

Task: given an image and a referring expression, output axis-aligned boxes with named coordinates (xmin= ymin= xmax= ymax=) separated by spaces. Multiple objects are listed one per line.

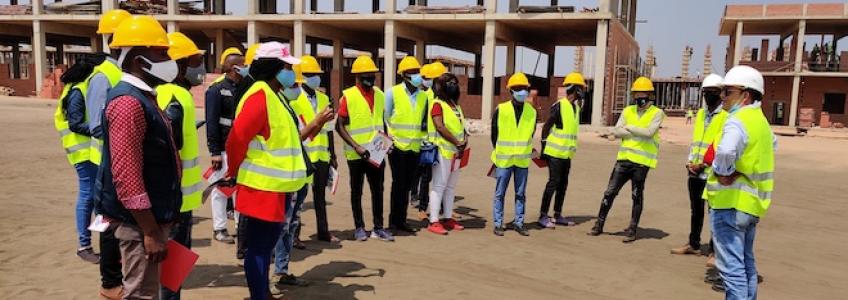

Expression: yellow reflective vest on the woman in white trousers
xmin=427 ymin=99 xmax=465 ymax=159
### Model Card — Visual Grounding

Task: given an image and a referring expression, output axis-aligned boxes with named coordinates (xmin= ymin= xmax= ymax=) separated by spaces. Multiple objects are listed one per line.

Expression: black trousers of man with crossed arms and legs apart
xmin=598 ymin=160 xmax=650 ymax=229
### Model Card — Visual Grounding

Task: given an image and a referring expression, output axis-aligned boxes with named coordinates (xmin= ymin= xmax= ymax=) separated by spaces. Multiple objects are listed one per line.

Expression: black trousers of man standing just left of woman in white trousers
xmin=389 ymin=149 xmax=420 ymax=227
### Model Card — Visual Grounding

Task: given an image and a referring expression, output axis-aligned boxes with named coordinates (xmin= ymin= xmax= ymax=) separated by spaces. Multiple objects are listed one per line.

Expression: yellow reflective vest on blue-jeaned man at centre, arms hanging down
xmin=491 ymin=101 xmax=536 ymax=168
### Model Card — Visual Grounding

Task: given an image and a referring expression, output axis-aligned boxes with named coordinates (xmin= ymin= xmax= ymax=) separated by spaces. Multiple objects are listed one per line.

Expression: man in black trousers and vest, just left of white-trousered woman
xmin=383 ymin=56 xmax=427 ymax=233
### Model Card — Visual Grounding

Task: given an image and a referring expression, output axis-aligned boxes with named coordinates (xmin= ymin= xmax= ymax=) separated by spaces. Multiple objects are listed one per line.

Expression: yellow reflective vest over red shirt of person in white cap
xmin=236 ymin=81 xmax=307 ymax=193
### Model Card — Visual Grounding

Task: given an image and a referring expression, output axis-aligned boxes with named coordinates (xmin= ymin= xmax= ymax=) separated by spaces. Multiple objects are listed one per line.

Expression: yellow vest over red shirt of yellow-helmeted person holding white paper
xmin=342 ymin=86 xmax=385 ymax=160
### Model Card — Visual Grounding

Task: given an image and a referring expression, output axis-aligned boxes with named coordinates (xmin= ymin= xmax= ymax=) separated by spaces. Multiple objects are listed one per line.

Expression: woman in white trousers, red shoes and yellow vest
xmin=427 ymin=73 xmax=468 ymax=235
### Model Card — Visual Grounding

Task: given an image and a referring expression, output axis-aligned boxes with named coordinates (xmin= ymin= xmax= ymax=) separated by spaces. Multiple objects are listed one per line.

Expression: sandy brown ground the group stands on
xmin=0 ymin=99 xmax=848 ymax=299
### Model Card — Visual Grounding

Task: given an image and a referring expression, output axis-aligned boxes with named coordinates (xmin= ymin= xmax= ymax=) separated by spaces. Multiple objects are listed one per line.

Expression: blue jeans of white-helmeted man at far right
xmin=710 ymin=209 xmax=760 ymax=300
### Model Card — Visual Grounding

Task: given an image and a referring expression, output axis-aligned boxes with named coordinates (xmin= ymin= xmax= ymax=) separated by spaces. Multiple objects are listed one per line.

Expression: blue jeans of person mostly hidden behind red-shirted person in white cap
xmin=274 ymin=189 xmax=309 ymax=274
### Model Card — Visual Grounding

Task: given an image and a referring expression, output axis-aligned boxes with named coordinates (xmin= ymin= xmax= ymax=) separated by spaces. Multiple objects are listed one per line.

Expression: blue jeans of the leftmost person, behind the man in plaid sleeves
xmin=74 ymin=161 xmax=97 ymax=248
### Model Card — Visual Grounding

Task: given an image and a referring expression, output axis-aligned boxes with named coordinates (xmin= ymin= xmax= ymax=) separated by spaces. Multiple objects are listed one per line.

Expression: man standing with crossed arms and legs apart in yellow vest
xmin=589 ymin=77 xmax=665 ymax=243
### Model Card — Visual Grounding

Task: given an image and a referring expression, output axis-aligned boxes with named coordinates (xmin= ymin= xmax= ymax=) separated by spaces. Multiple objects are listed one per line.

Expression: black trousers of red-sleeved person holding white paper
xmin=347 ymin=159 xmax=386 ymax=229
